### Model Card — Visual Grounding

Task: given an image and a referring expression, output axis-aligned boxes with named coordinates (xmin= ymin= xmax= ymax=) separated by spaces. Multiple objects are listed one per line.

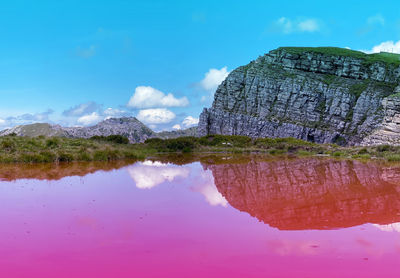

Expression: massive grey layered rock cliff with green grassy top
xmin=198 ymin=48 xmax=400 ymax=145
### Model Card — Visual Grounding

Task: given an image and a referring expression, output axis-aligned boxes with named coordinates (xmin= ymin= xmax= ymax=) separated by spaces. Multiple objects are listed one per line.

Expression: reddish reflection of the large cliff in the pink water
xmin=203 ymin=159 xmax=400 ymax=230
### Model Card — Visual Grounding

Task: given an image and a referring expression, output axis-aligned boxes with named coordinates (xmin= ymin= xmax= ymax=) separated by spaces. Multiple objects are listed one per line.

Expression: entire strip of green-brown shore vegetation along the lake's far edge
xmin=0 ymin=134 xmax=400 ymax=163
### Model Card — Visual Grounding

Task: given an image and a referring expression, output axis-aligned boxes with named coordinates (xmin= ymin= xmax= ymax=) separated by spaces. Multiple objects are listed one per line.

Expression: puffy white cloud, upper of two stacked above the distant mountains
xmin=127 ymin=86 xmax=189 ymax=108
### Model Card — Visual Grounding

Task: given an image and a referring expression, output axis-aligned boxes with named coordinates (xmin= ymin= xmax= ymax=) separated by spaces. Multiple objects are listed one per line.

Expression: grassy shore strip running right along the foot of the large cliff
xmin=144 ymin=135 xmax=400 ymax=161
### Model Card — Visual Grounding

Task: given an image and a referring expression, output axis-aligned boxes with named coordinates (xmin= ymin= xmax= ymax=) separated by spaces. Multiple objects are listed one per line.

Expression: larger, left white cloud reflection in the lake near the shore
xmin=128 ymin=161 xmax=189 ymax=189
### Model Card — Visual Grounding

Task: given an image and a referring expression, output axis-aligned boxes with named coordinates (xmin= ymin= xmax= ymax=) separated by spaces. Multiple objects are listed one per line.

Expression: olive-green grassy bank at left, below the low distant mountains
xmin=0 ymin=135 xmax=151 ymax=163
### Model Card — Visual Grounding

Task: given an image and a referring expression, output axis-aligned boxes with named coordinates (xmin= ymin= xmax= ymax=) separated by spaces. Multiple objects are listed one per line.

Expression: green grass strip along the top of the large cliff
xmin=274 ymin=47 xmax=400 ymax=66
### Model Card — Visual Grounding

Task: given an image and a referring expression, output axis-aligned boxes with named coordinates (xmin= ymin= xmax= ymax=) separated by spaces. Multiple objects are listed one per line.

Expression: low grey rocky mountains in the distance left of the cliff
xmin=0 ymin=117 xmax=197 ymax=143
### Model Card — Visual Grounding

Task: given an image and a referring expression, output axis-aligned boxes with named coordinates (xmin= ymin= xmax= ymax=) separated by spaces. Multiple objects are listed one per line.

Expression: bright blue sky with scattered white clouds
xmin=0 ymin=0 xmax=400 ymax=130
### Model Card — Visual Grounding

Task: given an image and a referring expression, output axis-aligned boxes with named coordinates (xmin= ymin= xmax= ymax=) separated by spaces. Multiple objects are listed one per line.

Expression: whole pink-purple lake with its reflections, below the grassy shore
xmin=0 ymin=156 xmax=400 ymax=278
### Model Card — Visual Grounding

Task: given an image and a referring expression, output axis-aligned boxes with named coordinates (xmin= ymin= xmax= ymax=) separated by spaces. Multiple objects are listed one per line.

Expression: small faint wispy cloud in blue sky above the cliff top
xmin=274 ymin=17 xmax=321 ymax=34
